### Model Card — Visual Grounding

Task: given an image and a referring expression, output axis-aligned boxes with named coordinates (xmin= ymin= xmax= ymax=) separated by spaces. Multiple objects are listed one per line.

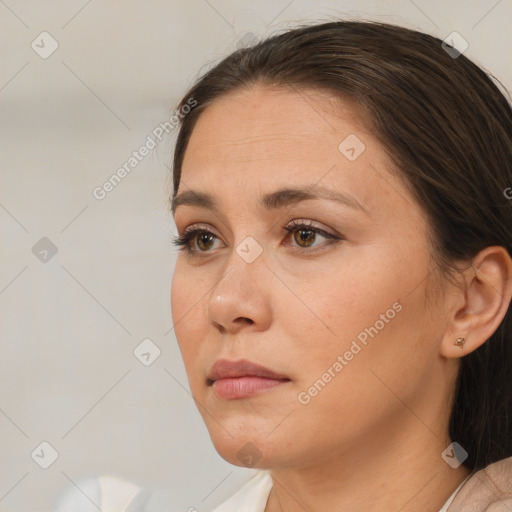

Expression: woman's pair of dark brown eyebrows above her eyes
xmin=171 ymin=185 xmax=370 ymax=215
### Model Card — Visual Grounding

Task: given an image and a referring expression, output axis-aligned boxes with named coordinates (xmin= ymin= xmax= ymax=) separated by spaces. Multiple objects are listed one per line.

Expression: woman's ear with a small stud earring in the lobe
xmin=440 ymin=246 xmax=512 ymax=358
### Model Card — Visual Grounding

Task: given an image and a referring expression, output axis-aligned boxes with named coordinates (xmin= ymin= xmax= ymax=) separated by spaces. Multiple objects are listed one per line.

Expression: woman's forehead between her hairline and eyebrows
xmin=179 ymin=85 xmax=412 ymax=218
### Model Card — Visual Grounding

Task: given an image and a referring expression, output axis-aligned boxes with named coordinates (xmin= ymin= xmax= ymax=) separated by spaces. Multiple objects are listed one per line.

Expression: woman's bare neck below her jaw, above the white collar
xmin=265 ymin=418 xmax=470 ymax=512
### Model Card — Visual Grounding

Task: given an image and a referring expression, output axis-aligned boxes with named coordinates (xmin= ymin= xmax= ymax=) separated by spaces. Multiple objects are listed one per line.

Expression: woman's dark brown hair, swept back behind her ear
xmin=173 ymin=21 xmax=512 ymax=470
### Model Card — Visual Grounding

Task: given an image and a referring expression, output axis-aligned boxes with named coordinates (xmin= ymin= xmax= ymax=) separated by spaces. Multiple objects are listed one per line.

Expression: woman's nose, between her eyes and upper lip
xmin=206 ymin=251 xmax=272 ymax=334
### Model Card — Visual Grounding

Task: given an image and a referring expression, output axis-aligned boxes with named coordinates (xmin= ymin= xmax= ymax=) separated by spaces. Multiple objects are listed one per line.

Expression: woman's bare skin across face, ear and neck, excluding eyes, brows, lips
xmin=171 ymin=85 xmax=512 ymax=512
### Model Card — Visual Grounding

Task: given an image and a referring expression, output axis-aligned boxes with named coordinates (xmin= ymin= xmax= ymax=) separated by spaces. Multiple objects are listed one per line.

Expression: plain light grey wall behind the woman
xmin=0 ymin=0 xmax=512 ymax=511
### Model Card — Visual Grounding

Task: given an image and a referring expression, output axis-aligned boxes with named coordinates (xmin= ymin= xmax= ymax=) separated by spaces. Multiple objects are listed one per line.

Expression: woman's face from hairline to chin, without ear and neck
xmin=172 ymin=86 xmax=453 ymax=468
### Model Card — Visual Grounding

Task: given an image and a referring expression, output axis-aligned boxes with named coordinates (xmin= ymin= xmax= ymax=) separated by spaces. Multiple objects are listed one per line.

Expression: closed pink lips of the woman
xmin=206 ymin=359 xmax=291 ymax=400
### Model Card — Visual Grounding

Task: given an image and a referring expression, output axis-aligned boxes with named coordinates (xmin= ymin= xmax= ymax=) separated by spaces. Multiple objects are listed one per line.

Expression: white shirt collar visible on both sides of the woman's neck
xmin=212 ymin=470 xmax=469 ymax=512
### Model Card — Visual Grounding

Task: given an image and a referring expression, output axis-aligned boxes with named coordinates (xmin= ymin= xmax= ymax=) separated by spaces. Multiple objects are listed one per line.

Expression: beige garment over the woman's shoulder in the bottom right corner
xmin=448 ymin=457 xmax=512 ymax=512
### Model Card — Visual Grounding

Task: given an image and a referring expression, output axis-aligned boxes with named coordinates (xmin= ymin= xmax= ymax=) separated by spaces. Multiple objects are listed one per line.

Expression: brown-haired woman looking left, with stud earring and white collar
xmin=171 ymin=21 xmax=512 ymax=512
